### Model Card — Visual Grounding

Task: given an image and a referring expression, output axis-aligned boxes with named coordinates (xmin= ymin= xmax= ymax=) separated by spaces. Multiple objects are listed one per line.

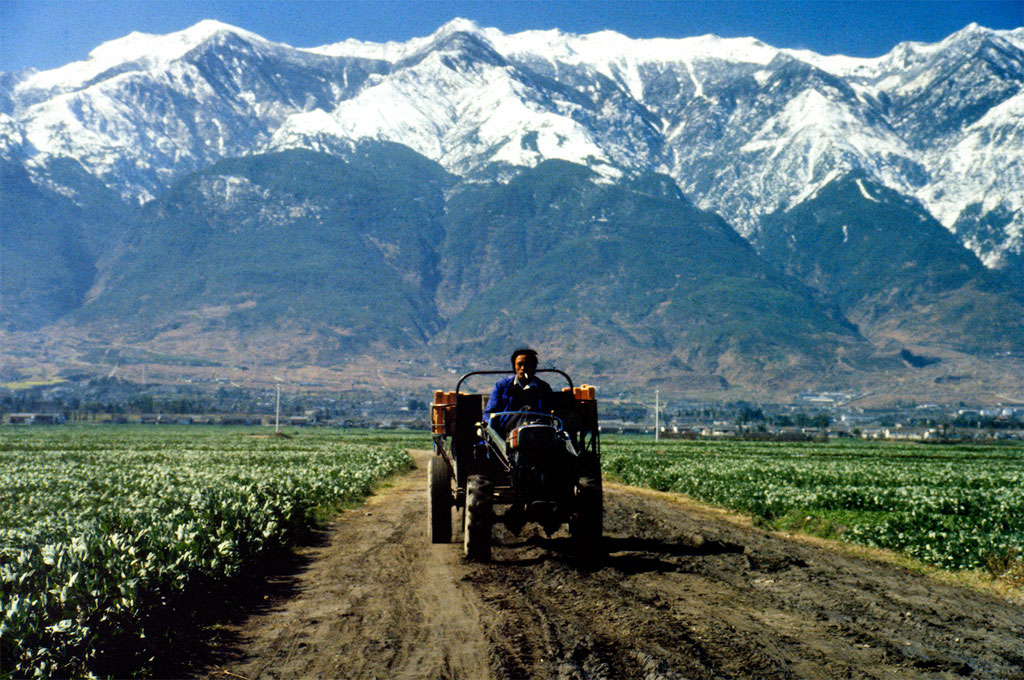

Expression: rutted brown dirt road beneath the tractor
xmin=201 ymin=453 xmax=1024 ymax=680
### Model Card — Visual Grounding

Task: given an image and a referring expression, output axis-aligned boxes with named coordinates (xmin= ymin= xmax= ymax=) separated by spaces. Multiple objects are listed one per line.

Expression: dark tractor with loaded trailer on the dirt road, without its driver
xmin=428 ymin=369 xmax=603 ymax=561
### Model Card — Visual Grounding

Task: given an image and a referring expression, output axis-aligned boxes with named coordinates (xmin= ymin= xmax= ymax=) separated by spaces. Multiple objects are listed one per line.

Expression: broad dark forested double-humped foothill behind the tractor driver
xmin=58 ymin=153 xmax=878 ymax=389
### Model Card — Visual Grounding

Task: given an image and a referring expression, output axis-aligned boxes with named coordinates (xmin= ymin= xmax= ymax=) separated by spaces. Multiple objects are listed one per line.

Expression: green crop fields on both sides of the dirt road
xmin=0 ymin=426 xmax=1024 ymax=678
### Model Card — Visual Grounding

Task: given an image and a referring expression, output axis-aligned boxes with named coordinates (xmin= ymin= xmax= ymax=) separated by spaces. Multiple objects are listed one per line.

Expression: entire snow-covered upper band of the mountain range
xmin=0 ymin=19 xmax=1024 ymax=267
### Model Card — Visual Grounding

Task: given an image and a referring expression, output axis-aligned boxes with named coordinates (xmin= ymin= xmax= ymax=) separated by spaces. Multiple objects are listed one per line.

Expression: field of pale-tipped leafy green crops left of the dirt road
xmin=0 ymin=427 xmax=411 ymax=677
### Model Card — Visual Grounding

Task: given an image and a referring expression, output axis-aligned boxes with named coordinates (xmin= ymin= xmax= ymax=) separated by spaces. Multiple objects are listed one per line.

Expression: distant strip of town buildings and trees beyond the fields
xmin=0 ymin=378 xmax=1024 ymax=441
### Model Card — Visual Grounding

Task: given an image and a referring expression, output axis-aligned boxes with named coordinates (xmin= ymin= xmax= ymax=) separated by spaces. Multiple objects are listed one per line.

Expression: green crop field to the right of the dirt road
xmin=602 ymin=437 xmax=1024 ymax=576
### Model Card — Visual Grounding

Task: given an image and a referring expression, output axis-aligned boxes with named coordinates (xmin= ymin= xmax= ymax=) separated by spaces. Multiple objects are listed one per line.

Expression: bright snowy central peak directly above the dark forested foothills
xmin=271 ymin=25 xmax=645 ymax=180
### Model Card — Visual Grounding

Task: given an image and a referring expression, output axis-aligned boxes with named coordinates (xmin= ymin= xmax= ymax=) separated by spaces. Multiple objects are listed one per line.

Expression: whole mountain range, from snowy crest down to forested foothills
xmin=0 ymin=20 xmax=1024 ymax=401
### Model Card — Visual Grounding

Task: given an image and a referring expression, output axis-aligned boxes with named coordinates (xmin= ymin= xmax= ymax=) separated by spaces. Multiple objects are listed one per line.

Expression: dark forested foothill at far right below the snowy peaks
xmin=758 ymin=173 xmax=1024 ymax=353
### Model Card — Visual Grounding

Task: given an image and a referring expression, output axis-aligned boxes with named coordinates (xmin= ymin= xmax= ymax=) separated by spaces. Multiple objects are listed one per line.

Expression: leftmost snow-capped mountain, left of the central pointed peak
xmin=0 ymin=20 xmax=386 ymax=202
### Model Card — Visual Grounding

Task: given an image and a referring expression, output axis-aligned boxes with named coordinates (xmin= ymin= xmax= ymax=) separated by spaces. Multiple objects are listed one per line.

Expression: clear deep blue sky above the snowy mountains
xmin=0 ymin=0 xmax=1024 ymax=71
